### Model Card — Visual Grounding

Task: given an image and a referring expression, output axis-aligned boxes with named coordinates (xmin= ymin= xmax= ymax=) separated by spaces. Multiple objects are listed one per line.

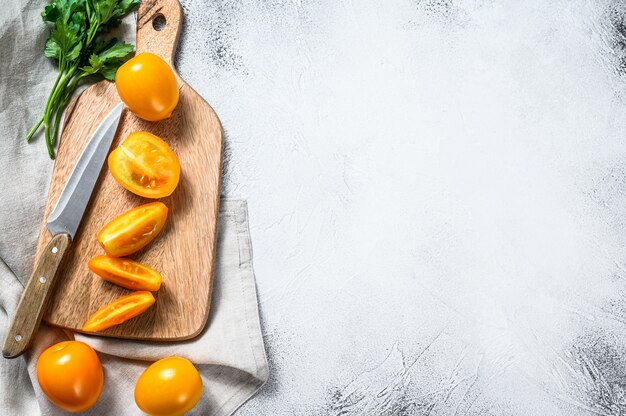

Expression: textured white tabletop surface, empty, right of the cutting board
xmin=178 ymin=0 xmax=626 ymax=416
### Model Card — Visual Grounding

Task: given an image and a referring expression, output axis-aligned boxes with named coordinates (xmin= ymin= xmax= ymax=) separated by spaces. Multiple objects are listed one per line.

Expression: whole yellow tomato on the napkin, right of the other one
xmin=135 ymin=357 xmax=202 ymax=416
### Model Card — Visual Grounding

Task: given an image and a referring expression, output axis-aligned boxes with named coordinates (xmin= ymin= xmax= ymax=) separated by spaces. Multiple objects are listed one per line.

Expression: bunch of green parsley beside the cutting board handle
xmin=26 ymin=0 xmax=139 ymax=159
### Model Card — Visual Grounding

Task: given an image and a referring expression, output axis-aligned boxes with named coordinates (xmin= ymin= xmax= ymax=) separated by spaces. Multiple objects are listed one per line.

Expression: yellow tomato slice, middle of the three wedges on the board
xmin=87 ymin=256 xmax=161 ymax=292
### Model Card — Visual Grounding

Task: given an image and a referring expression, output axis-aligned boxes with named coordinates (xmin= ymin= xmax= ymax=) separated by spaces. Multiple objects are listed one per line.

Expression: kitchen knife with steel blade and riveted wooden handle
xmin=2 ymin=103 xmax=123 ymax=358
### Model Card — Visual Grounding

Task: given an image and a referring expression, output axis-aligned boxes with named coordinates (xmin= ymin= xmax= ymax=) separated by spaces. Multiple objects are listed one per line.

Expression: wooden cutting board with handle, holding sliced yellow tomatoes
xmin=37 ymin=0 xmax=223 ymax=340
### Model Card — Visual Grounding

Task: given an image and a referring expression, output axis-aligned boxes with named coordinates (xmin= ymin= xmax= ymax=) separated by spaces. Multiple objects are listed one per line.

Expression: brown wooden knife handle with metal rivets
xmin=2 ymin=233 xmax=70 ymax=358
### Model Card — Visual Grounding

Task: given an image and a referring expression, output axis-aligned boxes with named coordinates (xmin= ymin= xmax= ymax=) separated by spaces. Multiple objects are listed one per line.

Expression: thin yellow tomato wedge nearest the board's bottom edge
xmin=83 ymin=291 xmax=154 ymax=332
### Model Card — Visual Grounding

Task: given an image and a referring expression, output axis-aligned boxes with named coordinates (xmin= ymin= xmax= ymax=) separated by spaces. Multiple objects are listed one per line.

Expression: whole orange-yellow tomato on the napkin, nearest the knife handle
xmin=37 ymin=341 xmax=103 ymax=412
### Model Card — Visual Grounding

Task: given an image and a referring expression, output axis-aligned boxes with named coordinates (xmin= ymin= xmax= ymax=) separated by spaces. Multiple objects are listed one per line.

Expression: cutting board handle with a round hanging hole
xmin=137 ymin=0 xmax=183 ymax=68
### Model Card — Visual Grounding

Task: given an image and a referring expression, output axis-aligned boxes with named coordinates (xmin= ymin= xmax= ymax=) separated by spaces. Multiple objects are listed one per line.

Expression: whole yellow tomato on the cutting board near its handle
xmin=115 ymin=52 xmax=178 ymax=121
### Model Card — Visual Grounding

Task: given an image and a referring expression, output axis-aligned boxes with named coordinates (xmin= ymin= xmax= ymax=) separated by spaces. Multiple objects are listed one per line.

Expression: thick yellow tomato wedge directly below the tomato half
xmin=98 ymin=202 xmax=167 ymax=257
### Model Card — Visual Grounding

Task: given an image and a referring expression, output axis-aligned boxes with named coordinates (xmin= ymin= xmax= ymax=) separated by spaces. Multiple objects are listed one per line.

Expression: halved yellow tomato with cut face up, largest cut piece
xmin=108 ymin=131 xmax=180 ymax=198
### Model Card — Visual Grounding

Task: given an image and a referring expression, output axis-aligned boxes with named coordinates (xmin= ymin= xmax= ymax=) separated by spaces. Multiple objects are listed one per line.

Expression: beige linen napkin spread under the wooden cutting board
xmin=0 ymin=0 xmax=268 ymax=415
